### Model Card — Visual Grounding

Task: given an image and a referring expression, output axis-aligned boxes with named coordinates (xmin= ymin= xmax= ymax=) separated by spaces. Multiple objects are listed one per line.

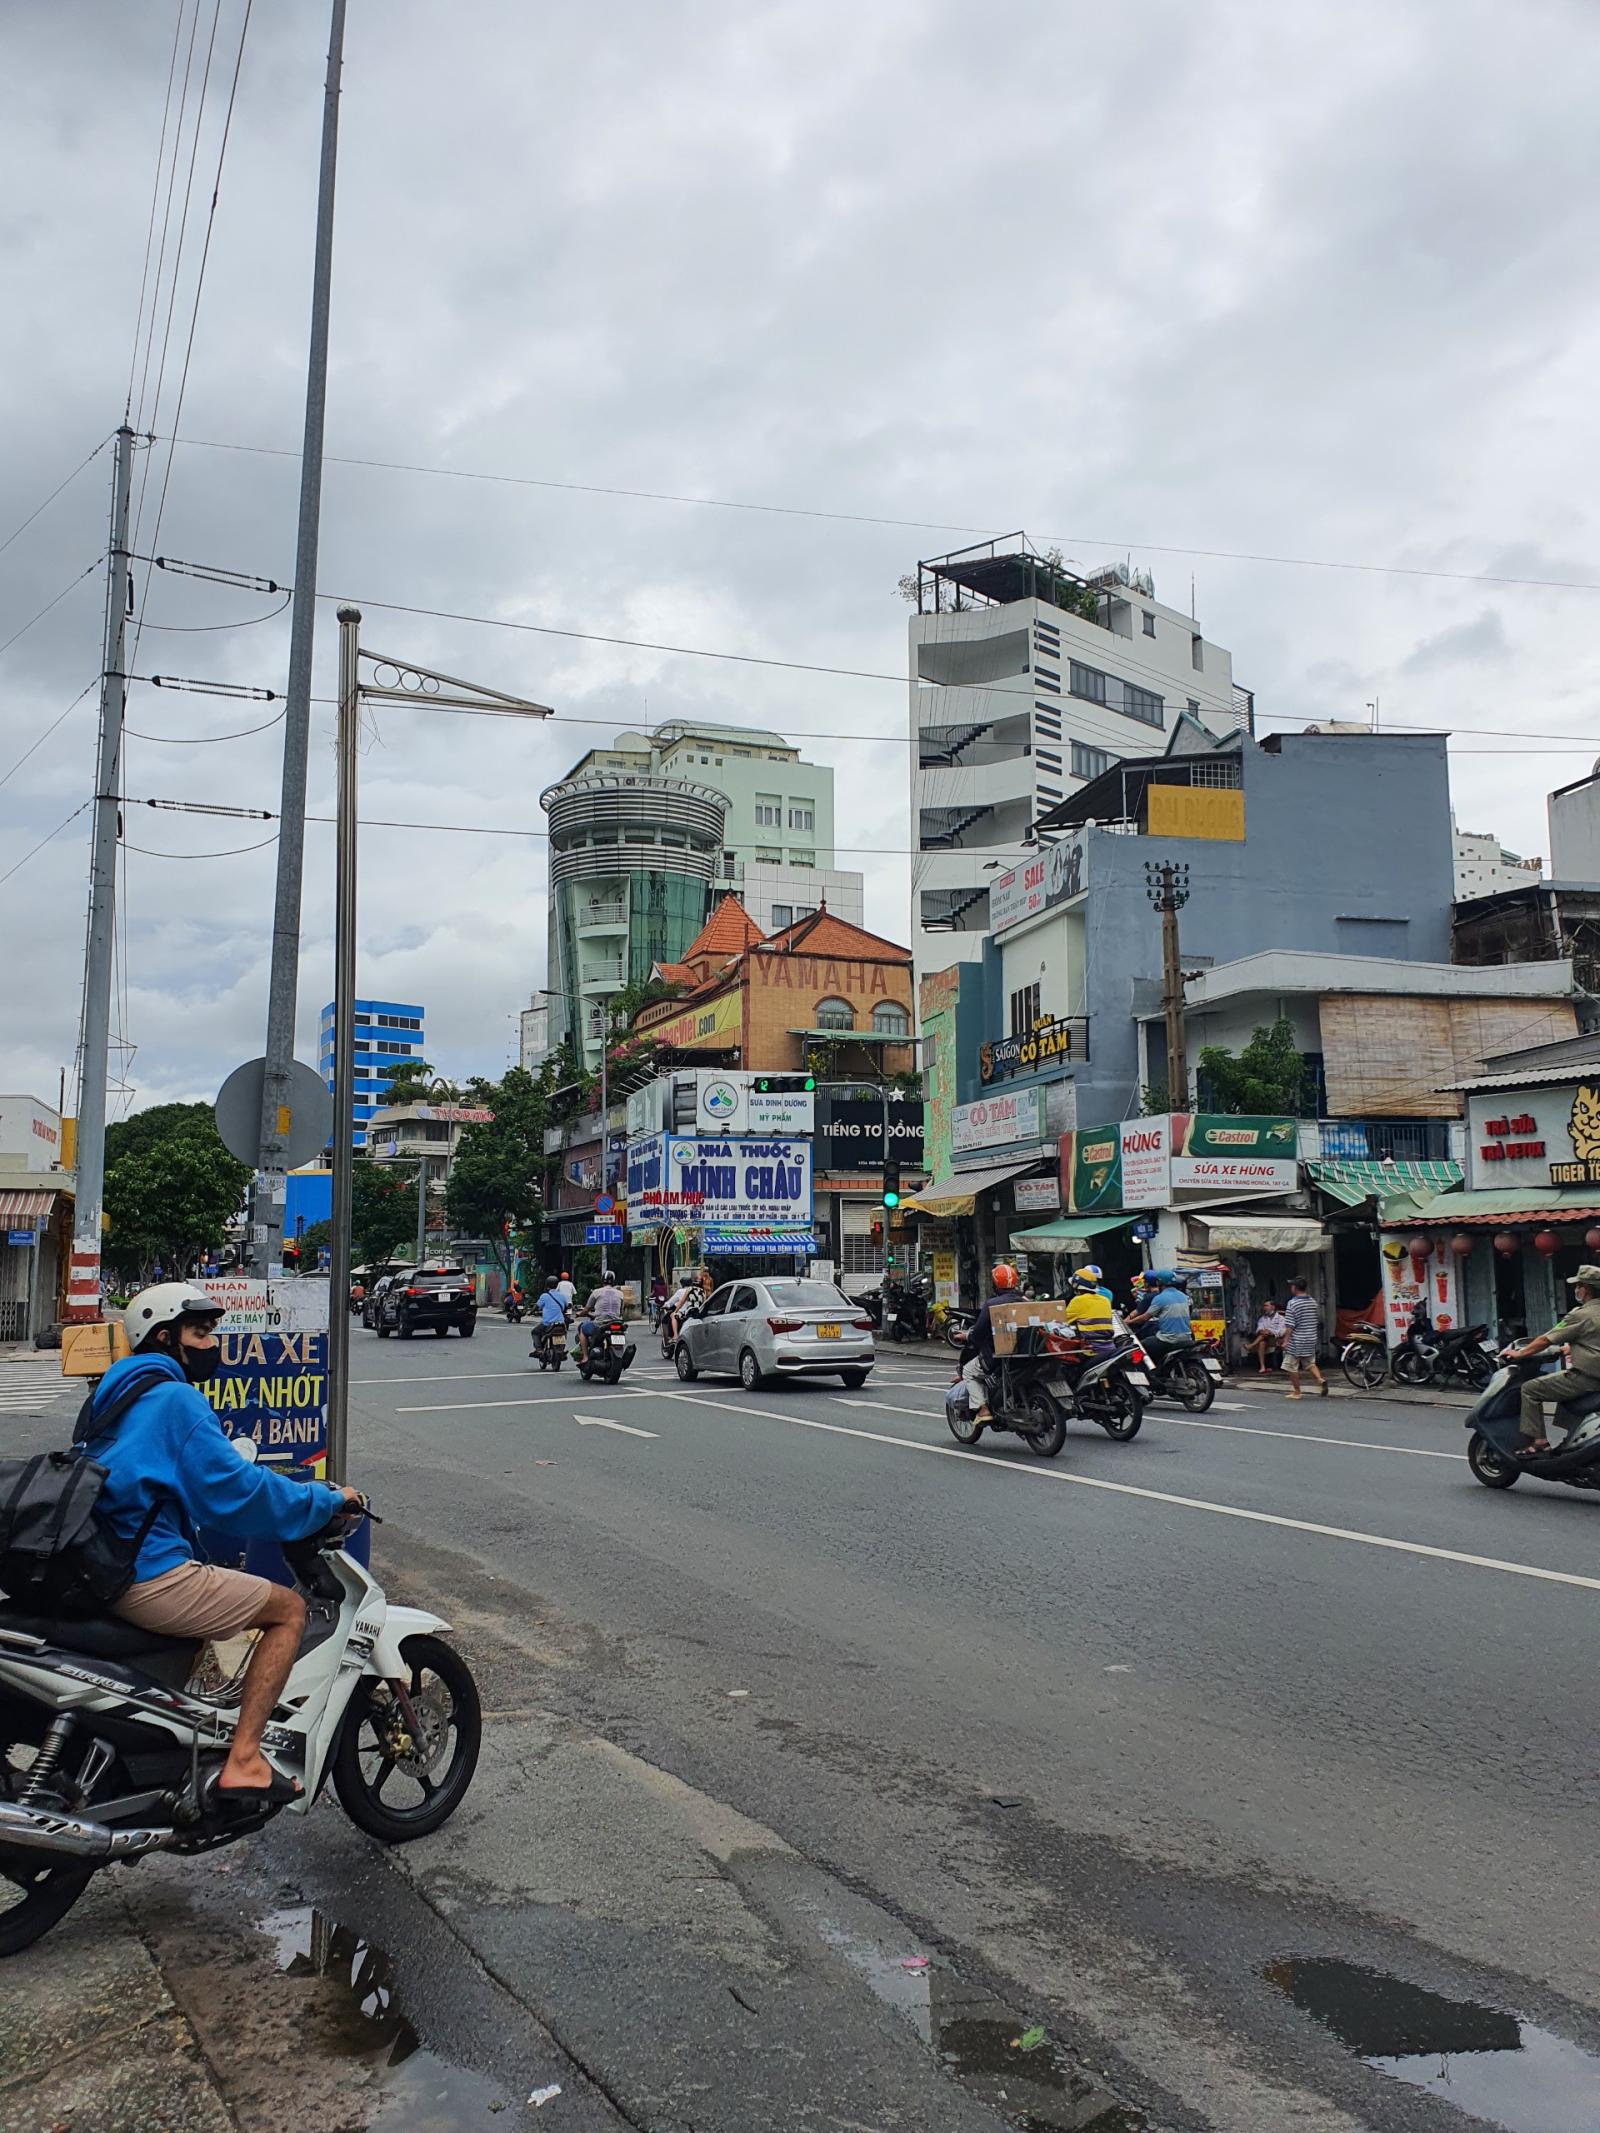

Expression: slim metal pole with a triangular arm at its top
xmin=329 ymin=608 xmax=550 ymax=1482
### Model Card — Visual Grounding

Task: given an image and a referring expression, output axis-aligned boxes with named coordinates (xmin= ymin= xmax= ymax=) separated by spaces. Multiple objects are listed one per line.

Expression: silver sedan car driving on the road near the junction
xmin=674 ymin=1278 xmax=877 ymax=1393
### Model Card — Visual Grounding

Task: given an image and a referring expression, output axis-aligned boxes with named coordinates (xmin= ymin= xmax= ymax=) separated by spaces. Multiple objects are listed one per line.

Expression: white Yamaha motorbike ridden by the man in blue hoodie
xmin=0 ymin=1446 xmax=482 ymax=1956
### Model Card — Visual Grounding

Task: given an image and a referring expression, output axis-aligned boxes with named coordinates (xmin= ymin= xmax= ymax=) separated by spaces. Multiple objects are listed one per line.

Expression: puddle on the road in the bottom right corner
xmin=1261 ymin=1956 xmax=1600 ymax=2133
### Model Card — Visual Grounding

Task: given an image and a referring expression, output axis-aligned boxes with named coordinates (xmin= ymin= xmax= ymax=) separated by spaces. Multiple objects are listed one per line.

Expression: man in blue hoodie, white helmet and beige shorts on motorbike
xmin=81 ymin=1282 xmax=361 ymax=1800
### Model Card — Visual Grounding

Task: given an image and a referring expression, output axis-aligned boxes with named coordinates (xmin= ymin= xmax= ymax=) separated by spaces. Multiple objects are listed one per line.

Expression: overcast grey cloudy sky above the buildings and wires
xmin=0 ymin=0 xmax=1600 ymax=1103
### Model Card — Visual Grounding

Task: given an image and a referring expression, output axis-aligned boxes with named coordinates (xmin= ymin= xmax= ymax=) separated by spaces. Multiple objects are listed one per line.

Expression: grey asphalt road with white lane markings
xmin=9 ymin=1316 xmax=1600 ymax=2133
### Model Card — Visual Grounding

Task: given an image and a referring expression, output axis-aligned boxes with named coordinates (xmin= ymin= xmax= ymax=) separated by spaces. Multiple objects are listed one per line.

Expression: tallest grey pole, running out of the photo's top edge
xmin=252 ymin=0 xmax=346 ymax=1278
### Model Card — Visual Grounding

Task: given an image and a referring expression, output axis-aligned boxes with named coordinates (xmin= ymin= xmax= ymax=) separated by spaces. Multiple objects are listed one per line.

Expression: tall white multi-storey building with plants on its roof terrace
xmin=909 ymin=533 xmax=1254 ymax=973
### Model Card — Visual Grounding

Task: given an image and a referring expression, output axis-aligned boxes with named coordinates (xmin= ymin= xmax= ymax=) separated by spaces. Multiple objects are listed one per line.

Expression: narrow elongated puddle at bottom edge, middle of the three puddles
xmin=817 ymin=1915 xmax=1152 ymax=2133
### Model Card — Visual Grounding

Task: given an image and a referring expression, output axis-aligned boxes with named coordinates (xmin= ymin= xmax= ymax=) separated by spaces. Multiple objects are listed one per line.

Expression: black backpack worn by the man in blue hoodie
xmin=0 ymin=1369 xmax=171 ymax=1617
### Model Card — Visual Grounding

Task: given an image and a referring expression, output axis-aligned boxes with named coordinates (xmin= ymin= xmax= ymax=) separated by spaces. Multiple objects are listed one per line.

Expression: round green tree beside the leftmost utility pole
xmin=105 ymin=1103 xmax=250 ymax=1282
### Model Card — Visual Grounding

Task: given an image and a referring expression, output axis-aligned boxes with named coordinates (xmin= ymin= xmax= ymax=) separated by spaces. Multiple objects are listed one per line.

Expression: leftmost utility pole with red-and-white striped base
xmin=66 ymin=422 xmax=134 ymax=1322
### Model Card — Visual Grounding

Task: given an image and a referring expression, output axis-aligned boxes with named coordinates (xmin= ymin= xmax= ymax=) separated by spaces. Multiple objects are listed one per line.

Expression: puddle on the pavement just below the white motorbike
xmin=258 ymin=1907 xmax=510 ymax=2133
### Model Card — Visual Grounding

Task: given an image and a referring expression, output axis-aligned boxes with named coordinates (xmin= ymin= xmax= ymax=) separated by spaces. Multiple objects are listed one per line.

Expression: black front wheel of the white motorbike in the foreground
xmin=333 ymin=1636 xmax=482 ymax=1845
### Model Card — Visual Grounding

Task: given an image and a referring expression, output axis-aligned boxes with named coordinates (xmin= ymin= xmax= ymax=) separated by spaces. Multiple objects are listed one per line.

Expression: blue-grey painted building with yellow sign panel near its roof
xmin=954 ymin=721 xmax=1455 ymax=1134
